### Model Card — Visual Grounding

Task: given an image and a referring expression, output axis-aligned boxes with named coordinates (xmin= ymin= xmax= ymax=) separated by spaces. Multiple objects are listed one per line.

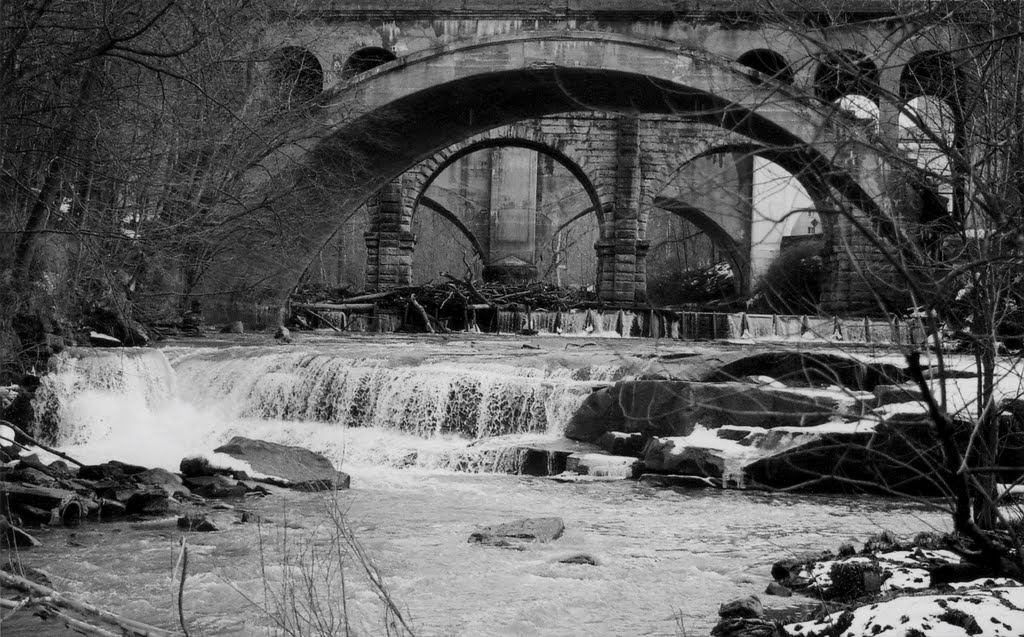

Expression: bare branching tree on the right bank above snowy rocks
xmin=712 ymin=0 xmax=1024 ymax=569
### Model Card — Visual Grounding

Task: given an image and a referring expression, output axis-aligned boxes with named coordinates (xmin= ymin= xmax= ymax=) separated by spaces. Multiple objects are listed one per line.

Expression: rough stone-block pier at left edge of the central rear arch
xmin=364 ymin=177 xmax=416 ymax=290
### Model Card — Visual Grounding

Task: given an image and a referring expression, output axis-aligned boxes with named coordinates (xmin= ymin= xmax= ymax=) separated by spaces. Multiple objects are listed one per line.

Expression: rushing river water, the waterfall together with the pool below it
xmin=12 ymin=339 xmax=946 ymax=637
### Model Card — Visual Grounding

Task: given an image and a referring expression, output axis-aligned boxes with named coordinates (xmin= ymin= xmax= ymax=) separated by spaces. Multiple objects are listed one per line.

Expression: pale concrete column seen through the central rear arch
xmin=483 ymin=147 xmax=537 ymax=283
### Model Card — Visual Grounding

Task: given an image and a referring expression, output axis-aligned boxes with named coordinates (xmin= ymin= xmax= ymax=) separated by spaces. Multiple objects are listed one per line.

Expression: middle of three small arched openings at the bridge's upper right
xmin=814 ymin=50 xmax=880 ymax=123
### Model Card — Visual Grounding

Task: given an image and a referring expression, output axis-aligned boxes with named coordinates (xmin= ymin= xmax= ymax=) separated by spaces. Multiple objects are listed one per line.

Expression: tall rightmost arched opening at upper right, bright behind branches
xmin=899 ymin=51 xmax=964 ymax=225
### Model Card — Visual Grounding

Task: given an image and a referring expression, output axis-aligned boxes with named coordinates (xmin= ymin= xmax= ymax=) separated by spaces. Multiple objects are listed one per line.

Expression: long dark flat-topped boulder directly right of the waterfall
xmin=565 ymin=380 xmax=846 ymax=442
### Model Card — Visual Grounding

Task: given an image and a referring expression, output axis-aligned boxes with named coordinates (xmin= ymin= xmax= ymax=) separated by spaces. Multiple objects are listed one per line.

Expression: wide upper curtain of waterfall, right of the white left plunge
xmin=175 ymin=348 xmax=593 ymax=439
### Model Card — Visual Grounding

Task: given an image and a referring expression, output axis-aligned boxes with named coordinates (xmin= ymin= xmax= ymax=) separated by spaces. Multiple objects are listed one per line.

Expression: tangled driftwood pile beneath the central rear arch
xmin=292 ymin=274 xmax=600 ymax=333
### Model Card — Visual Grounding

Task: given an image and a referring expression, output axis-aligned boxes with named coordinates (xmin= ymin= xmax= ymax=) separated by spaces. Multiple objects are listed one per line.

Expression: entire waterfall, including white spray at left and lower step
xmin=37 ymin=345 xmax=623 ymax=471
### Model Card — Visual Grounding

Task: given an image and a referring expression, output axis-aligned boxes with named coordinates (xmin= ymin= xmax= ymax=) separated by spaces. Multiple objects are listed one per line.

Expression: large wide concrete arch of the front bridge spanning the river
xmin=211 ymin=31 xmax=886 ymax=311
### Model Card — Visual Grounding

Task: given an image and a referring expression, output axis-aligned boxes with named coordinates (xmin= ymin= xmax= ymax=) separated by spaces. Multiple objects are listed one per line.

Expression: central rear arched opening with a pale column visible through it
xmin=413 ymin=138 xmax=600 ymax=288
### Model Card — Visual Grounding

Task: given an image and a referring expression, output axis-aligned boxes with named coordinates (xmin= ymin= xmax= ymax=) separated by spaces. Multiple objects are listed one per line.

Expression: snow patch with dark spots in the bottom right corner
xmin=785 ymin=587 xmax=1024 ymax=637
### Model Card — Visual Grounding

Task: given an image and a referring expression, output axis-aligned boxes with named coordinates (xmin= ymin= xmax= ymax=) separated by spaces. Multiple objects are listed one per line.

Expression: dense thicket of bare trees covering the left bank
xmin=0 ymin=0 xmax=344 ymax=374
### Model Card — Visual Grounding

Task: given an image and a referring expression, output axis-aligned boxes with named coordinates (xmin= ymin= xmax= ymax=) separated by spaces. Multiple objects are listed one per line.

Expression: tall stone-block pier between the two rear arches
xmin=595 ymin=116 xmax=647 ymax=305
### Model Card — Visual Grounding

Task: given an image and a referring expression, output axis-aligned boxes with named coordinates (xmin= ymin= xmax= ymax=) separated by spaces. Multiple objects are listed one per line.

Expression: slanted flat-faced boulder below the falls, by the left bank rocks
xmin=214 ymin=436 xmax=349 ymax=491
